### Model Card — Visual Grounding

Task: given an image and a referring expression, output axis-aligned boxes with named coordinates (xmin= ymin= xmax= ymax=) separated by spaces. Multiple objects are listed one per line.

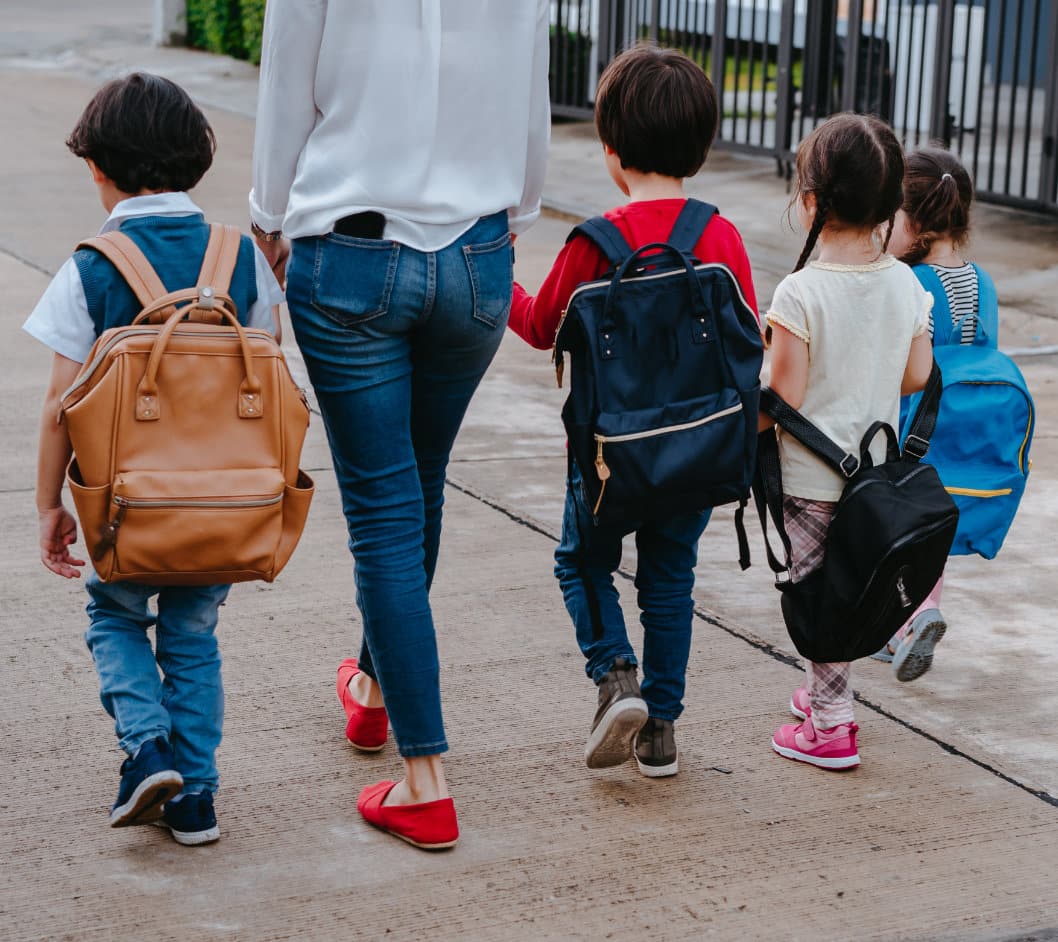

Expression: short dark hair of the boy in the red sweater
xmin=595 ymin=44 xmax=719 ymax=179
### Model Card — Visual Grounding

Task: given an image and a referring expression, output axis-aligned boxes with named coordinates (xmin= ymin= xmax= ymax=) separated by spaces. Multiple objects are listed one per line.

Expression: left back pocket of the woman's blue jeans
xmin=312 ymin=233 xmax=400 ymax=327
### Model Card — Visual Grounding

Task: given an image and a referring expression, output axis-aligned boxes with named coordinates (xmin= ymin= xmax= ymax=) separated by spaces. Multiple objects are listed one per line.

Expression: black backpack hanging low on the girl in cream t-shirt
xmin=753 ymin=363 xmax=959 ymax=663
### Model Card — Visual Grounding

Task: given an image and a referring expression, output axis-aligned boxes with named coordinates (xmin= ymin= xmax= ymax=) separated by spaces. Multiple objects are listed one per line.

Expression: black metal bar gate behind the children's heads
xmin=551 ymin=0 xmax=1058 ymax=212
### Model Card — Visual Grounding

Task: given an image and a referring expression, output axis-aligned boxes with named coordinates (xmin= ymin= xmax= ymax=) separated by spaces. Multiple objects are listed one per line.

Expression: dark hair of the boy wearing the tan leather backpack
xmin=66 ymin=72 xmax=217 ymax=193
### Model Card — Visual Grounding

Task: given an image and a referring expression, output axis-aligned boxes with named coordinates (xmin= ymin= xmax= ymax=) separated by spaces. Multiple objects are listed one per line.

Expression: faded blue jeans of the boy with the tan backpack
xmin=85 ymin=573 xmax=231 ymax=792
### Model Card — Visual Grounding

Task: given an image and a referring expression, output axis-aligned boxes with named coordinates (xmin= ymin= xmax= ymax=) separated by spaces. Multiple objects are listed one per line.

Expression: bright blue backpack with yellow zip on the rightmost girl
xmin=901 ymin=265 xmax=1036 ymax=559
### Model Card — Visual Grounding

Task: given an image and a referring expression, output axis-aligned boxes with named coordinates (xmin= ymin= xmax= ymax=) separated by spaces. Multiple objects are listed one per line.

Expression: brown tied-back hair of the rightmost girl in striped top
xmin=900 ymin=147 xmax=973 ymax=265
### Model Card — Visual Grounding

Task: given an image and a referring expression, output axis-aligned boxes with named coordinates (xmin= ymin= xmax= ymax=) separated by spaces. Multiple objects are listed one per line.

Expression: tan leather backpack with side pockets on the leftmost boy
xmin=59 ymin=225 xmax=313 ymax=585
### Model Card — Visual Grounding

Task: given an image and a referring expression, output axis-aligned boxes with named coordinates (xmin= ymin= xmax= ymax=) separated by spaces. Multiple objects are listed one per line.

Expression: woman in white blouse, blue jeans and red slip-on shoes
xmin=250 ymin=0 xmax=549 ymax=849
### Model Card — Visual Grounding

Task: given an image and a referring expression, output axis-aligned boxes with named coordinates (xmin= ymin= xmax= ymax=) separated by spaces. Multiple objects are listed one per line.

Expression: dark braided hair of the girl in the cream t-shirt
xmin=794 ymin=112 xmax=904 ymax=271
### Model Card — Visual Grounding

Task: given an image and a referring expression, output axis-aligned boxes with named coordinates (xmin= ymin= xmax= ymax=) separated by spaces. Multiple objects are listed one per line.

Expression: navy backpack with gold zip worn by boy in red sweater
xmin=554 ymin=199 xmax=763 ymax=531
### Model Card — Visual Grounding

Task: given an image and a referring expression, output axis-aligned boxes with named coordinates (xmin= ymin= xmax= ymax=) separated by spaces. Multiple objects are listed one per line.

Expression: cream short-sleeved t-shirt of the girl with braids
xmin=767 ymin=255 xmax=933 ymax=501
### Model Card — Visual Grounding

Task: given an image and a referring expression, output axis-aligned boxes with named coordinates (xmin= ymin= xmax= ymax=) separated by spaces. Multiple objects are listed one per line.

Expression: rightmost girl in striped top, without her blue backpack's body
xmin=873 ymin=147 xmax=999 ymax=681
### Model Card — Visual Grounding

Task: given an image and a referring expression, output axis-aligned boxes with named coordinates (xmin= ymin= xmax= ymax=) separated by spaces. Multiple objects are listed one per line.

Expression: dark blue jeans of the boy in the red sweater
xmin=554 ymin=460 xmax=710 ymax=720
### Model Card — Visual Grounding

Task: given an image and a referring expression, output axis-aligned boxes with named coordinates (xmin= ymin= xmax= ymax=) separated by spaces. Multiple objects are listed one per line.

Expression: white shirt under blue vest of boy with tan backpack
xmin=22 ymin=193 xmax=282 ymax=363
